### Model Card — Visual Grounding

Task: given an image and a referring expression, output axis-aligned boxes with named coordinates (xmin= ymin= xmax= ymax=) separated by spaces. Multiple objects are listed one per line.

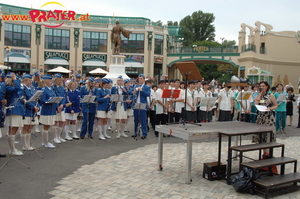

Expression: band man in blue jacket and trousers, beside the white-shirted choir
xmin=133 ymin=74 xmax=150 ymax=139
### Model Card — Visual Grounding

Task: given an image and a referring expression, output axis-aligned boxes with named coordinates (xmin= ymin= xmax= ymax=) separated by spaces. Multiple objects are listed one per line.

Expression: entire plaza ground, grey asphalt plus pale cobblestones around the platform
xmin=0 ymin=109 xmax=300 ymax=199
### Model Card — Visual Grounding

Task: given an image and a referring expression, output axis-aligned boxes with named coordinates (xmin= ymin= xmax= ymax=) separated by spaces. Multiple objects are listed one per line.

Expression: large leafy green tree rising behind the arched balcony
xmin=180 ymin=10 xmax=215 ymax=46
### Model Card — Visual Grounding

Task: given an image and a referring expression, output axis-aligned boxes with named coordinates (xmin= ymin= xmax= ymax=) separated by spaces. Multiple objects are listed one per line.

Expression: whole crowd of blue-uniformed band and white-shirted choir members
xmin=0 ymin=72 xmax=300 ymax=156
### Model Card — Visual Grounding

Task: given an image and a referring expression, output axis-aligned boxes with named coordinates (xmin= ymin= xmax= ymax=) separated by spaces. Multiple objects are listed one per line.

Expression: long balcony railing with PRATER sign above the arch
xmin=168 ymin=46 xmax=238 ymax=54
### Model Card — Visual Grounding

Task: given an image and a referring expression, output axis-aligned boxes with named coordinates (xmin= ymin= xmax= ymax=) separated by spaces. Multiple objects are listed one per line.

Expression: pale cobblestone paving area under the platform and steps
xmin=49 ymin=137 xmax=300 ymax=199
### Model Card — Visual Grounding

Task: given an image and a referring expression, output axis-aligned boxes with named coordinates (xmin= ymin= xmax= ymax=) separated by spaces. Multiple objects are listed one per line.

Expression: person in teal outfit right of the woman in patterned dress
xmin=274 ymin=84 xmax=287 ymax=133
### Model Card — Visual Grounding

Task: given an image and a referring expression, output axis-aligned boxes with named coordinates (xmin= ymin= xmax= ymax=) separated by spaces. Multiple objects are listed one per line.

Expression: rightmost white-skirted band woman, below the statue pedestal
xmin=111 ymin=75 xmax=128 ymax=138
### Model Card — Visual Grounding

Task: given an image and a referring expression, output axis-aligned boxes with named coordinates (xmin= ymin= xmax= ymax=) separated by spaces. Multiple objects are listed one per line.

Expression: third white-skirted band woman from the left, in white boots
xmin=40 ymin=75 xmax=57 ymax=148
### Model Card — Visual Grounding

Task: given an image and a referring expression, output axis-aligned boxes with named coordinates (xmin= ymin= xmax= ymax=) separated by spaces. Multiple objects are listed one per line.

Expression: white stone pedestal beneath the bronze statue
xmin=104 ymin=55 xmax=130 ymax=84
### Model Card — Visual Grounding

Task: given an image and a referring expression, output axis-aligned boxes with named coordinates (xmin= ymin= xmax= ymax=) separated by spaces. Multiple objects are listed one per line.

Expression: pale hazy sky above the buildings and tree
xmin=0 ymin=0 xmax=300 ymax=42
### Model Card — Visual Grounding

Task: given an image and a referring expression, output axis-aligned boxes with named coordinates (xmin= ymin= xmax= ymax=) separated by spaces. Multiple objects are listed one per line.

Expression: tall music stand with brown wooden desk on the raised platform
xmin=176 ymin=62 xmax=202 ymax=130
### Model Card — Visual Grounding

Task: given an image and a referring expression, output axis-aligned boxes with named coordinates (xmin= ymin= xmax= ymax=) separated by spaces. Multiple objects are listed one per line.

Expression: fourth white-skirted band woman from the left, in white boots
xmin=53 ymin=73 xmax=67 ymax=144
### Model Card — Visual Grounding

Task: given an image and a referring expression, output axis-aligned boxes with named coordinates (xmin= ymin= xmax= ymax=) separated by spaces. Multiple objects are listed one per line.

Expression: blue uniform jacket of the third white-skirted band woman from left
xmin=40 ymin=86 xmax=57 ymax=115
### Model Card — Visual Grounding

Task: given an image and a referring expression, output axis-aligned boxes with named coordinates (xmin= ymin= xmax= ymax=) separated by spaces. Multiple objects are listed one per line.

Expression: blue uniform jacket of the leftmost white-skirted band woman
xmin=5 ymin=79 xmax=25 ymax=116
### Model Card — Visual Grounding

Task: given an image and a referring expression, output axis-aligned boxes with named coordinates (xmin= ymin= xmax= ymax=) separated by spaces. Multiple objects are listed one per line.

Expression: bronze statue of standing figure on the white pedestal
xmin=111 ymin=21 xmax=132 ymax=55
